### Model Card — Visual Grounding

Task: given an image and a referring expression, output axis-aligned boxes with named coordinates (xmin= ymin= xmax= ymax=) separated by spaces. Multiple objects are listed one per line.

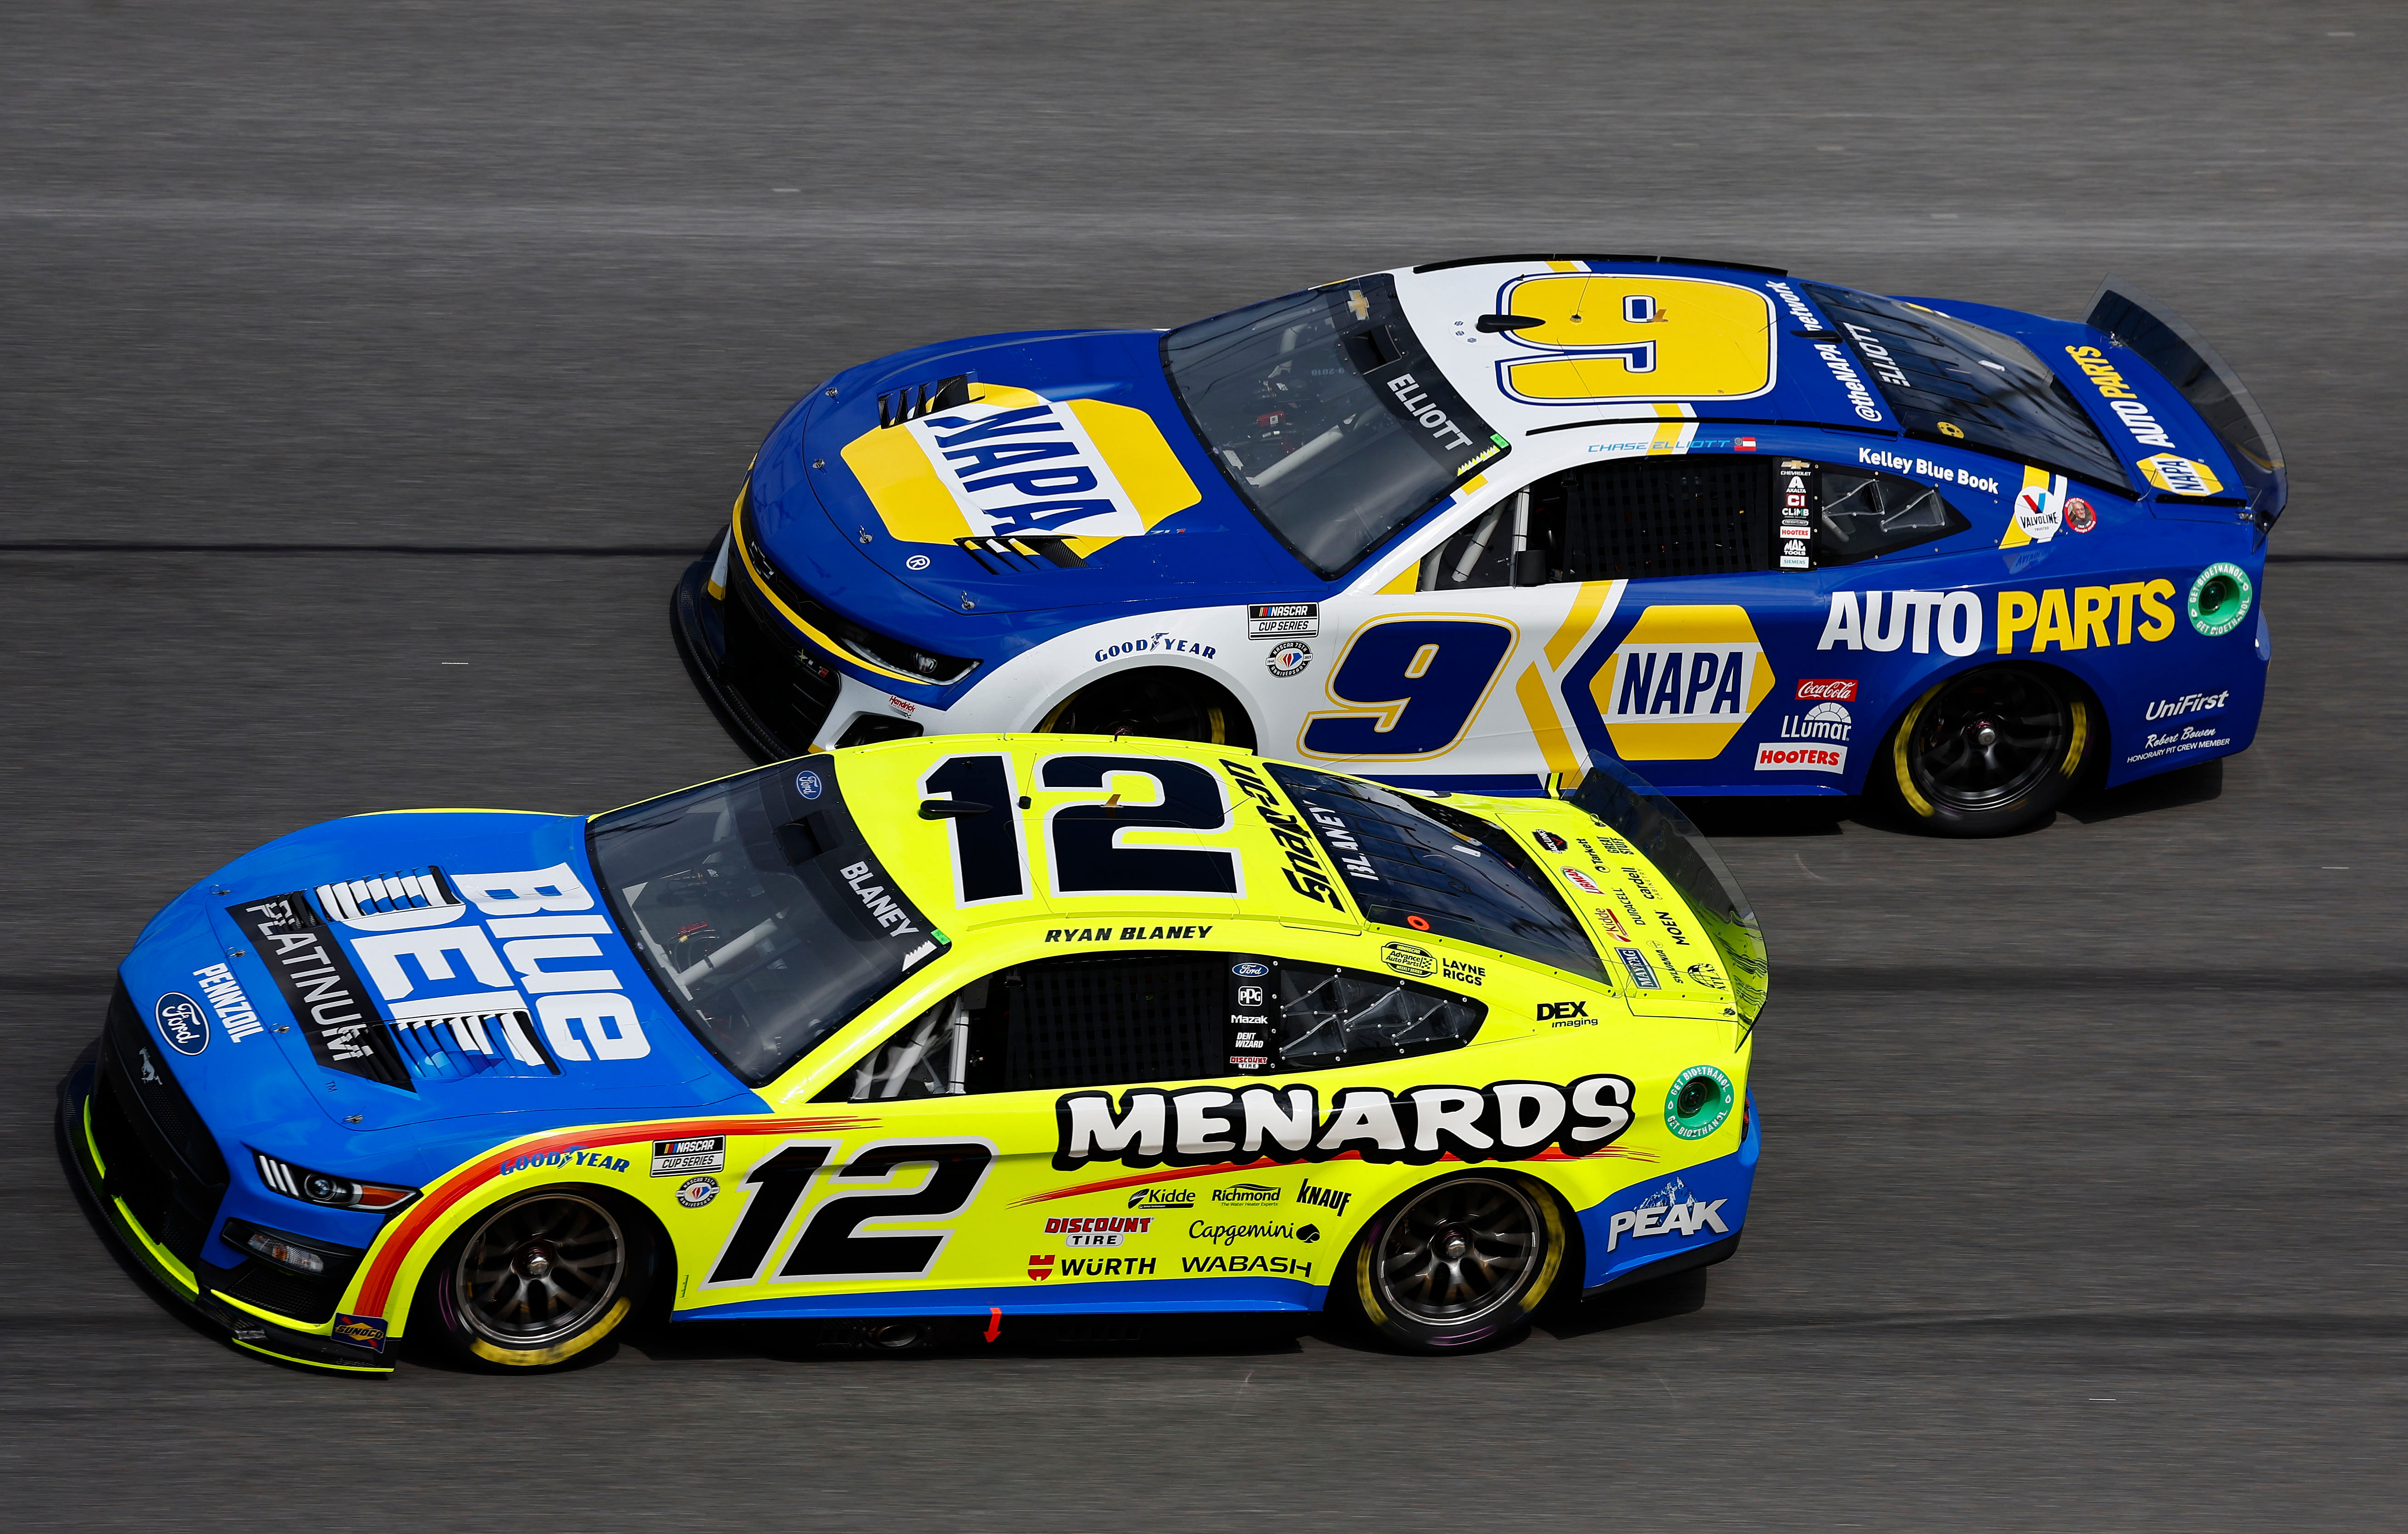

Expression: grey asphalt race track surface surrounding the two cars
xmin=0 ymin=0 xmax=2408 ymax=1529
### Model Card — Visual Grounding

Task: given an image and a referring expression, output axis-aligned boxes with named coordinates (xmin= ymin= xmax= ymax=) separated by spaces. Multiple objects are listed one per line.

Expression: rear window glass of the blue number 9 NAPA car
xmin=1806 ymin=284 xmax=2131 ymax=489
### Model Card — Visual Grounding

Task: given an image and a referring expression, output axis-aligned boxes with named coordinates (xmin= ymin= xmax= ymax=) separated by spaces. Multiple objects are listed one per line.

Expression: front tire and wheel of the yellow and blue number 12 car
xmin=419 ymin=1187 xmax=653 ymax=1373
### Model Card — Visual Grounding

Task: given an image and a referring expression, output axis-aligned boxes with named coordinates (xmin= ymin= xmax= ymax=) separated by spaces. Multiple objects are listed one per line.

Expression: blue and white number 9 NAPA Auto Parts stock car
xmin=674 ymin=258 xmax=2285 ymax=836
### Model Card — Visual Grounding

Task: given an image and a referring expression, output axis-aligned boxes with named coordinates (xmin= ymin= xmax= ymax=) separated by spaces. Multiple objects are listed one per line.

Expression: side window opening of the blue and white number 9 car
xmin=1418 ymin=455 xmax=1972 ymax=590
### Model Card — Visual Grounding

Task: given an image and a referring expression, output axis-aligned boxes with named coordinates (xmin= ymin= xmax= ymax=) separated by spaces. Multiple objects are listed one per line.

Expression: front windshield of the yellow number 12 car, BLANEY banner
xmin=590 ymin=756 xmax=946 ymax=1086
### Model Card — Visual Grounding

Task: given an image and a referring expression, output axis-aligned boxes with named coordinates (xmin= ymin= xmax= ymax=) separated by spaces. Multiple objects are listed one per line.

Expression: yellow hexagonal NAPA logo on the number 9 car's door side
xmin=1589 ymin=607 xmax=1772 ymax=761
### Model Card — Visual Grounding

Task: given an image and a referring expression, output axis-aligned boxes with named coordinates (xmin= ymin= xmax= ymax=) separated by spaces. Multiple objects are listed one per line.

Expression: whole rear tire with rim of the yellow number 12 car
xmin=1341 ymin=1173 xmax=1568 ymax=1353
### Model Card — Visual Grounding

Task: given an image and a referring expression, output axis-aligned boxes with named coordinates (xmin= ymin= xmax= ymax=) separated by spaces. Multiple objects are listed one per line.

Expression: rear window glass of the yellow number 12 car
xmin=1269 ymin=764 xmax=1606 ymax=980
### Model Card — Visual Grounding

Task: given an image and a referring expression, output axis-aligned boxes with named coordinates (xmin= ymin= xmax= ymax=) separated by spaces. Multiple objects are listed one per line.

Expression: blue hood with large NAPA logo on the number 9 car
xmin=751 ymin=330 xmax=1320 ymax=616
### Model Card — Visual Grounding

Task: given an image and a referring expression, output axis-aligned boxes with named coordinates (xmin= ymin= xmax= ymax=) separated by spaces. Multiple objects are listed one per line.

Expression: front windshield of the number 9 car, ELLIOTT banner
xmin=1163 ymin=277 xmax=1508 ymax=576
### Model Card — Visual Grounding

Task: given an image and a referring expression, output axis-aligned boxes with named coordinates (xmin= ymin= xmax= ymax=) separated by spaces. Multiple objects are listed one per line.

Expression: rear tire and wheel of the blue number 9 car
xmin=1874 ymin=665 xmax=2097 ymax=836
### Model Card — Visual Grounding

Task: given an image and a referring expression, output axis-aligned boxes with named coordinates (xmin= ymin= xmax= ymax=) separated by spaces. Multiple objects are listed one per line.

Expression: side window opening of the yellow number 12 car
xmin=819 ymin=951 xmax=1488 ymax=1103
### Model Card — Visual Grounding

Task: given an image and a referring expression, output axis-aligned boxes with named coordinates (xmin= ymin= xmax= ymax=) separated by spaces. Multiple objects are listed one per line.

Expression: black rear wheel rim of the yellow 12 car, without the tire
xmin=1373 ymin=1178 xmax=1539 ymax=1327
